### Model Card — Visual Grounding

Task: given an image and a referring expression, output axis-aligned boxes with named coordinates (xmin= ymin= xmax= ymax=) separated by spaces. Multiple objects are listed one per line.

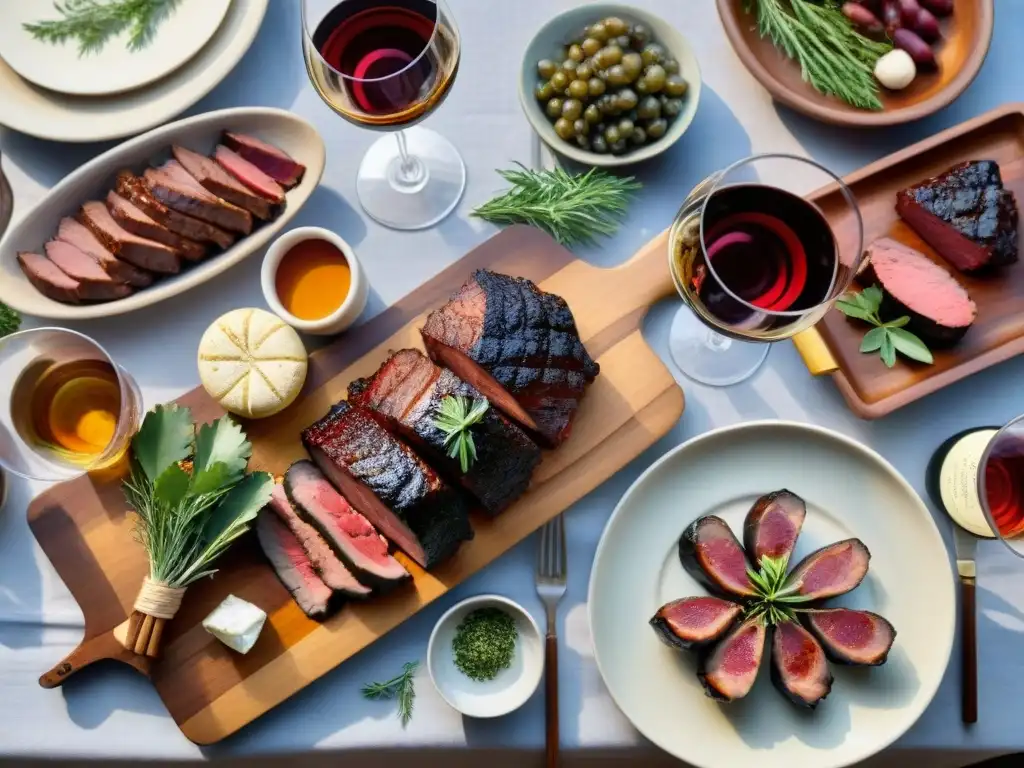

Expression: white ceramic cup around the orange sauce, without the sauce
xmin=260 ymin=226 xmax=370 ymax=336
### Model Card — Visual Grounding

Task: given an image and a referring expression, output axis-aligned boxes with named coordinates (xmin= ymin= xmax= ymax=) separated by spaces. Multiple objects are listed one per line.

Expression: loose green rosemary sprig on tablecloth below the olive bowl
xmin=473 ymin=163 xmax=641 ymax=246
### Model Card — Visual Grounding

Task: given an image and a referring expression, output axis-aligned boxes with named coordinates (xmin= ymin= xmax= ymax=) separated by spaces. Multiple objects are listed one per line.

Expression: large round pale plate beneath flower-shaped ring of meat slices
xmin=589 ymin=421 xmax=956 ymax=768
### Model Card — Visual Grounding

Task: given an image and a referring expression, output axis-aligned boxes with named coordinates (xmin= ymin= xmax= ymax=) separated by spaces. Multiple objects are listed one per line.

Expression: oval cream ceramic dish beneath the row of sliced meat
xmin=0 ymin=106 xmax=327 ymax=319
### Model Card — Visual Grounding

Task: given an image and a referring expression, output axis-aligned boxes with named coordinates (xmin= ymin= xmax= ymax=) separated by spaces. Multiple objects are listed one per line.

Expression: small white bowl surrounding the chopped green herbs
xmin=427 ymin=595 xmax=544 ymax=718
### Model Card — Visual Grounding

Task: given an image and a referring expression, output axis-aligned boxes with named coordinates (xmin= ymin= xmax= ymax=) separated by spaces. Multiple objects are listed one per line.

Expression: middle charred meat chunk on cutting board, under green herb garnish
xmin=348 ymin=349 xmax=541 ymax=514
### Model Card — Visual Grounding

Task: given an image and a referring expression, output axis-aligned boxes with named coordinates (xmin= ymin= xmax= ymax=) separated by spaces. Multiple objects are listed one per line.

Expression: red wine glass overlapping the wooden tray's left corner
xmin=669 ymin=154 xmax=865 ymax=386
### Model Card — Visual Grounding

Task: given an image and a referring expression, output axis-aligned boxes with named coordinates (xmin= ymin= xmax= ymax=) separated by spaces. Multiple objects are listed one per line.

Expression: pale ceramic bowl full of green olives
xmin=519 ymin=3 xmax=700 ymax=168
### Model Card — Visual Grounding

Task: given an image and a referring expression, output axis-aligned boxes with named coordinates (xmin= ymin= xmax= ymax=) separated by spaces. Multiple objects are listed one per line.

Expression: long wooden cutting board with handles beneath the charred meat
xmin=29 ymin=227 xmax=683 ymax=744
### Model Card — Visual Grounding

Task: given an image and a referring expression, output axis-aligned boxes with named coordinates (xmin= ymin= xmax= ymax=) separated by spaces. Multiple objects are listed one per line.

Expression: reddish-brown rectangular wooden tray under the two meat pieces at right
xmin=795 ymin=103 xmax=1024 ymax=419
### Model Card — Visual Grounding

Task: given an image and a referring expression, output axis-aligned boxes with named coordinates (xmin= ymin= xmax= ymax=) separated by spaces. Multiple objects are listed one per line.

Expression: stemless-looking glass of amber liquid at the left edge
xmin=0 ymin=328 xmax=142 ymax=481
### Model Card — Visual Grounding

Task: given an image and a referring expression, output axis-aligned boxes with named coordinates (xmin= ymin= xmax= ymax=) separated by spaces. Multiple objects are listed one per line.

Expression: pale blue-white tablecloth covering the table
xmin=0 ymin=0 xmax=1024 ymax=758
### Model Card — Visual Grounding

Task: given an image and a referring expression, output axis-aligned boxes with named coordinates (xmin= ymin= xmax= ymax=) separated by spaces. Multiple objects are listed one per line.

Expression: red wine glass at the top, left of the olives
xmin=302 ymin=0 xmax=466 ymax=229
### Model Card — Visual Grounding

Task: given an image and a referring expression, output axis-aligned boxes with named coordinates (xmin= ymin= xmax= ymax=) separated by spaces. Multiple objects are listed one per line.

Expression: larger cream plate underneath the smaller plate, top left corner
xmin=0 ymin=0 xmax=269 ymax=141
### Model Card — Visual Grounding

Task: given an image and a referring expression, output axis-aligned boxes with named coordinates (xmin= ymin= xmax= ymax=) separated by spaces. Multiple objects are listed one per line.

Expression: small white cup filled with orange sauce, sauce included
xmin=260 ymin=226 xmax=370 ymax=336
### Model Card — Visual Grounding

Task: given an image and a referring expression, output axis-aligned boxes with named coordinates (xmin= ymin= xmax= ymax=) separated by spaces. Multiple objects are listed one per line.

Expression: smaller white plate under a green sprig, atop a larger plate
xmin=0 ymin=0 xmax=231 ymax=96
